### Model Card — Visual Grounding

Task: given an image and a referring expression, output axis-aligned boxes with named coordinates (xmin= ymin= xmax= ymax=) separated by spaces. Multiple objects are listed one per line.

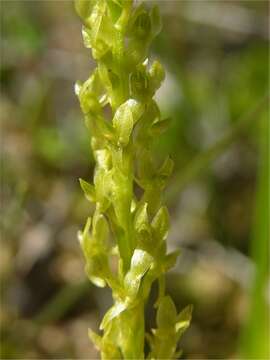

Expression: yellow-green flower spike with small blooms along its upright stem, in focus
xmin=75 ymin=0 xmax=192 ymax=359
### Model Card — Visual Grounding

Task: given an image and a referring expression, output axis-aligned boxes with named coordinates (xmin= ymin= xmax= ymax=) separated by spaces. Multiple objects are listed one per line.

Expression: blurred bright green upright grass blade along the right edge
xmin=239 ymin=108 xmax=270 ymax=359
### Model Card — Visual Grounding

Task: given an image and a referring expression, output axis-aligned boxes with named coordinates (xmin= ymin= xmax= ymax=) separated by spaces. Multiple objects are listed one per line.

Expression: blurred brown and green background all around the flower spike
xmin=0 ymin=0 xmax=270 ymax=359
